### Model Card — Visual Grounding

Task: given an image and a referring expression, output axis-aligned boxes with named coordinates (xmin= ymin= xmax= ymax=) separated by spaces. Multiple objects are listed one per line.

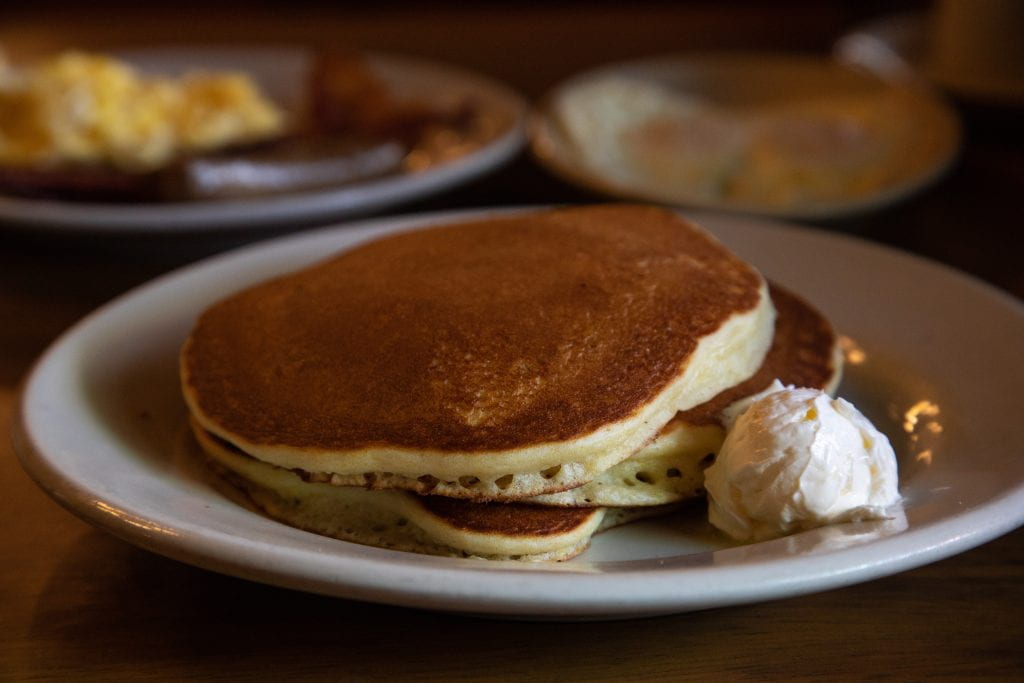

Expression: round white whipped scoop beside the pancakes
xmin=705 ymin=380 xmax=900 ymax=541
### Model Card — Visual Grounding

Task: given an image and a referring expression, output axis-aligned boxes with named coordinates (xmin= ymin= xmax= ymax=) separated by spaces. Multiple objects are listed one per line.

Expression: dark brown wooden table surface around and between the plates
xmin=0 ymin=3 xmax=1024 ymax=680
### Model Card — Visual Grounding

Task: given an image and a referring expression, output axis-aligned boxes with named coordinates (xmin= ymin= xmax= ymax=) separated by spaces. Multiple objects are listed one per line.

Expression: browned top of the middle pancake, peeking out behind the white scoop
xmin=675 ymin=283 xmax=837 ymax=425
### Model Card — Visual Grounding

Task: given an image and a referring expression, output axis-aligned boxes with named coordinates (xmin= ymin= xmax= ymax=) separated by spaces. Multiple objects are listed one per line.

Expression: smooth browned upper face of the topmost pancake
xmin=182 ymin=205 xmax=761 ymax=452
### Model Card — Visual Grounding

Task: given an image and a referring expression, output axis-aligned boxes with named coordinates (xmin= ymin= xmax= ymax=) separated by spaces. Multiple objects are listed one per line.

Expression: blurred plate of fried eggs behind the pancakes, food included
xmin=529 ymin=52 xmax=961 ymax=219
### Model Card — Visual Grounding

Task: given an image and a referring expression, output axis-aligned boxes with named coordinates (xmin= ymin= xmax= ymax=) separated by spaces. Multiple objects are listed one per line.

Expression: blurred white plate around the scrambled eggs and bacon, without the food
xmin=0 ymin=47 xmax=527 ymax=233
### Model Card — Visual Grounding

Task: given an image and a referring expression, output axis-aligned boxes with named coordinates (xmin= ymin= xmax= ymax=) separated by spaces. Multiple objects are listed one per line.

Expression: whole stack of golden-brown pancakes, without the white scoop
xmin=181 ymin=205 xmax=840 ymax=560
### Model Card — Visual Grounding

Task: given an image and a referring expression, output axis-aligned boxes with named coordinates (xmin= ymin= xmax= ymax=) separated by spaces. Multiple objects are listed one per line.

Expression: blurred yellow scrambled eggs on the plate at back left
xmin=0 ymin=52 xmax=285 ymax=172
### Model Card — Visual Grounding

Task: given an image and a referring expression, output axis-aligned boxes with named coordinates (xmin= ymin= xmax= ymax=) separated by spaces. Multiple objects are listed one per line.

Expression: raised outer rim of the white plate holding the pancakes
xmin=11 ymin=207 xmax=1024 ymax=618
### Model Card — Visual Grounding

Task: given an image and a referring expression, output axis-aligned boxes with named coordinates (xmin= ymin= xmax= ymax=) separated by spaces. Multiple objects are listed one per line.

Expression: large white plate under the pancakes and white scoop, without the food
xmin=15 ymin=206 xmax=1024 ymax=618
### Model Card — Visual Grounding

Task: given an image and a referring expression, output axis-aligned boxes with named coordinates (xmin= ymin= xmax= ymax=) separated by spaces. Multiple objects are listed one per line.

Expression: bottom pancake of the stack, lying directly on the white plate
xmin=193 ymin=423 xmax=675 ymax=561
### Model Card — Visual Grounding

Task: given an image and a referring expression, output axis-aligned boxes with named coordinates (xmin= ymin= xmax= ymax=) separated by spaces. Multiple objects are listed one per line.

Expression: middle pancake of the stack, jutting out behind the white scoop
xmin=528 ymin=284 xmax=843 ymax=506
